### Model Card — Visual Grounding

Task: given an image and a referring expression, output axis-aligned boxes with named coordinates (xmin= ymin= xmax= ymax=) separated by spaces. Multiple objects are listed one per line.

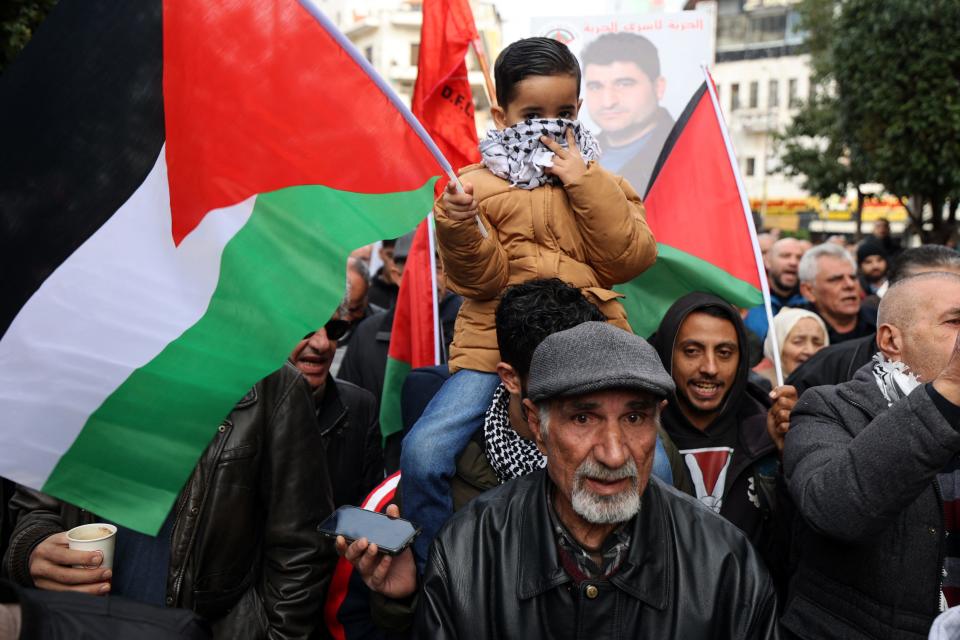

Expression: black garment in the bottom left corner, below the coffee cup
xmin=0 ymin=581 xmax=210 ymax=640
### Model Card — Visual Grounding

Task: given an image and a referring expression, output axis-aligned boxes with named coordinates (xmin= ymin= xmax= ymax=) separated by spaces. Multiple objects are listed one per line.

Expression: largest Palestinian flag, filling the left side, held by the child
xmin=0 ymin=0 xmax=446 ymax=534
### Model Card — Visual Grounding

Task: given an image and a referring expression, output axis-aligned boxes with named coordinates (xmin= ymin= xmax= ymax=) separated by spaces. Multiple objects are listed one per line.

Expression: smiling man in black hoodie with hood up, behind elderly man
xmin=650 ymin=293 xmax=786 ymax=579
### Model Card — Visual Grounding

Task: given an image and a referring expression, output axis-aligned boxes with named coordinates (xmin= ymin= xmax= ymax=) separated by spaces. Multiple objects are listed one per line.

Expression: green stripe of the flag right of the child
xmin=614 ymin=244 xmax=763 ymax=337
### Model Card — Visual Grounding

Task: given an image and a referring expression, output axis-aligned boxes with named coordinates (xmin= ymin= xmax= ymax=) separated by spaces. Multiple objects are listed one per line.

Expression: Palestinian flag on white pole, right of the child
xmin=615 ymin=75 xmax=769 ymax=336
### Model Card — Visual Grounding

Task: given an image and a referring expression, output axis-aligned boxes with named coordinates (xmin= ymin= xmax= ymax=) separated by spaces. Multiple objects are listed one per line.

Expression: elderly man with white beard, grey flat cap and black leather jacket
xmin=406 ymin=322 xmax=777 ymax=639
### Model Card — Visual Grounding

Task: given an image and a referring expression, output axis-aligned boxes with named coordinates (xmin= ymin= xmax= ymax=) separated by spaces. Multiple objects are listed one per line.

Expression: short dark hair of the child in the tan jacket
xmin=493 ymin=38 xmax=580 ymax=108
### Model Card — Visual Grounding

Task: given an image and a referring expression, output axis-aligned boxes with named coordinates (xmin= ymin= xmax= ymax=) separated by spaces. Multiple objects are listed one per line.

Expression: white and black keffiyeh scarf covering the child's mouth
xmin=480 ymin=118 xmax=600 ymax=189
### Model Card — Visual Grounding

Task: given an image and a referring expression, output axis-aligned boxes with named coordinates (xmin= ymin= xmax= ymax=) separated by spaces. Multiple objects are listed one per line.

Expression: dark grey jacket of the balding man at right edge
xmin=783 ymin=365 xmax=960 ymax=640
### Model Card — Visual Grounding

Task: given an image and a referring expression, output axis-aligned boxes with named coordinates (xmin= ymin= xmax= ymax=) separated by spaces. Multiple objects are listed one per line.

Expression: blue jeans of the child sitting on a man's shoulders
xmin=400 ymin=369 xmax=673 ymax=573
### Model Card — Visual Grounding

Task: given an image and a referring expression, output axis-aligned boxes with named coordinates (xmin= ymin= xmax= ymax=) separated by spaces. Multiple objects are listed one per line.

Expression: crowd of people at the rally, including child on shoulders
xmin=0 ymin=38 xmax=960 ymax=640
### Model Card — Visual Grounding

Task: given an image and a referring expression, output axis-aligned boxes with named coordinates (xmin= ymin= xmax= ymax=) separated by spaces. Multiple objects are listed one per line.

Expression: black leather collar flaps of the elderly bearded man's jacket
xmin=517 ymin=471 xmax=673 ymax=610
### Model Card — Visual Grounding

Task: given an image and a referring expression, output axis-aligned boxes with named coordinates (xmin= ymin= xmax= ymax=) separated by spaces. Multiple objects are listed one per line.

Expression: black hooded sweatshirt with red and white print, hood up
xmin=650 ymin=293 xmax=778 ymax=548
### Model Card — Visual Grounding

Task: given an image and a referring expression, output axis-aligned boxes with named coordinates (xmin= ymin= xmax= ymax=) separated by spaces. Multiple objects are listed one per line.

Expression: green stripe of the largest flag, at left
xmin=43 ymin=178 xmax=436 ymax=535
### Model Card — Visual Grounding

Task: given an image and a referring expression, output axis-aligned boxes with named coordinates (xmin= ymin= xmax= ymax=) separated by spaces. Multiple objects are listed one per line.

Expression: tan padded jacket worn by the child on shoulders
xmin=436 ymin=163 xmax=657 ymax=372
